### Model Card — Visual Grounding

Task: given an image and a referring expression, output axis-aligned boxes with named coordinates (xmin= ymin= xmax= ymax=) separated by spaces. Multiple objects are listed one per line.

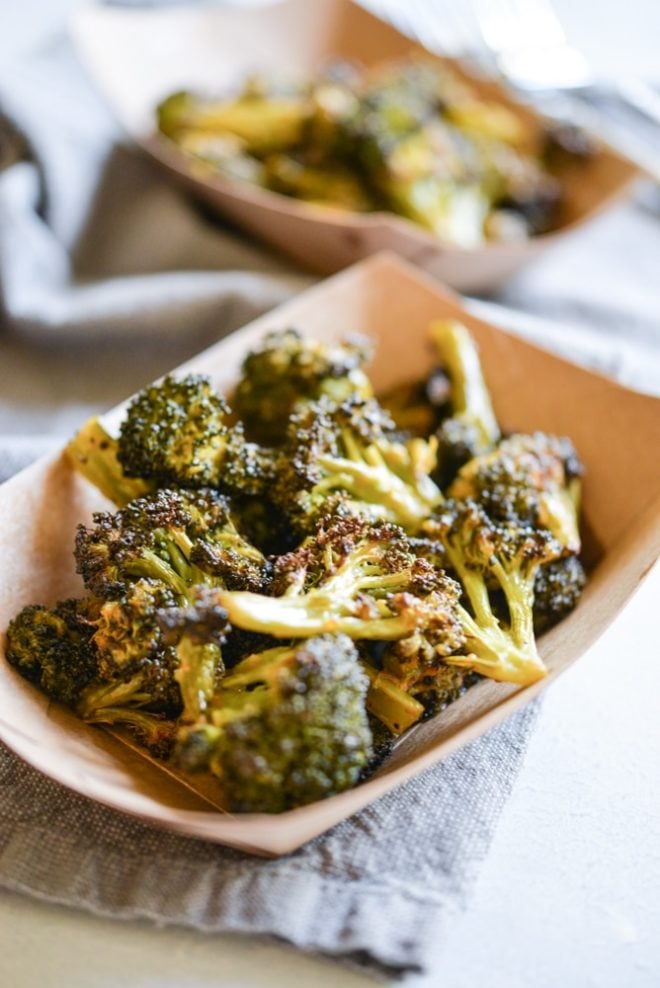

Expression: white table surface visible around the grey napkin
xmin=0 ymin=0 xmax=660 ymax=988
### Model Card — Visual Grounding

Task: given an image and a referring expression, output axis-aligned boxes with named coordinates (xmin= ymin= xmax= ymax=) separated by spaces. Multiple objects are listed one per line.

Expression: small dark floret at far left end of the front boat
xmin=7 ymin=599 xmax=98 ymax=706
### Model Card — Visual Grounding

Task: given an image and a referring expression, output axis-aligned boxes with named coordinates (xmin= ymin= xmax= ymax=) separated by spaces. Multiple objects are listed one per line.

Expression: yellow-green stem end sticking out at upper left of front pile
xmin=65 ymin=418 xmax=153 ymax=508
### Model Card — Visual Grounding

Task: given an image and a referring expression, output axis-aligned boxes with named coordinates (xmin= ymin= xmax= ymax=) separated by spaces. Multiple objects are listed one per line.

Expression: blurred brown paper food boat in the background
xmin=72 ymin=0 xmax=637 ymax=292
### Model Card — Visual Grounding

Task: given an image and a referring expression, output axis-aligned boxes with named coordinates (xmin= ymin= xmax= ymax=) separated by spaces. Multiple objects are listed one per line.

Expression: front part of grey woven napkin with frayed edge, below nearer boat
xmin=0 ymin=707 xmax=534 ymax=974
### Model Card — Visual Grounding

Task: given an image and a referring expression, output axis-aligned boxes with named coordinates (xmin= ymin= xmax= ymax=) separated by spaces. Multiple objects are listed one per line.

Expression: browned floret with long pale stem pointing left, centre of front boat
xmin=217 ymin=514 xmax=452 ymax=641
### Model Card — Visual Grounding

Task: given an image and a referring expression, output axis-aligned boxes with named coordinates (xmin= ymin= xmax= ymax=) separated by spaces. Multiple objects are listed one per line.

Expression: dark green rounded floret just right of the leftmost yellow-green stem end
xmin=117 ymin=374 xmax=276 ymax=495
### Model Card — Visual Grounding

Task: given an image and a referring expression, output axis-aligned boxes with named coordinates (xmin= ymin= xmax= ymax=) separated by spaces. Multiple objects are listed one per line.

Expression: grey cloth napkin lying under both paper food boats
xmin=0 ymin=11 xmax=660 ymax=975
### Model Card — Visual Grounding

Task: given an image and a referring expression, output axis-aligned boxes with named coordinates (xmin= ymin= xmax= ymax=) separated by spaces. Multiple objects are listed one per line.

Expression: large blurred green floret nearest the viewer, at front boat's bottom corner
xmin=176 ymin=635 xmax=372 ymax=813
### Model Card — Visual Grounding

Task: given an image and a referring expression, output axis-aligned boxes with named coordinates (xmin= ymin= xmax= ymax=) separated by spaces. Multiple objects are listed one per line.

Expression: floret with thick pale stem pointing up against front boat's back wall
xmin=430 ymin=319 xmax=500 ymax=487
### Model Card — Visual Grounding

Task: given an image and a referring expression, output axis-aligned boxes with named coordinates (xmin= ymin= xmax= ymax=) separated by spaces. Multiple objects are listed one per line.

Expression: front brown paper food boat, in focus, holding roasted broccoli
xmin=0 ymin=255 xmax=660 ymax=855
